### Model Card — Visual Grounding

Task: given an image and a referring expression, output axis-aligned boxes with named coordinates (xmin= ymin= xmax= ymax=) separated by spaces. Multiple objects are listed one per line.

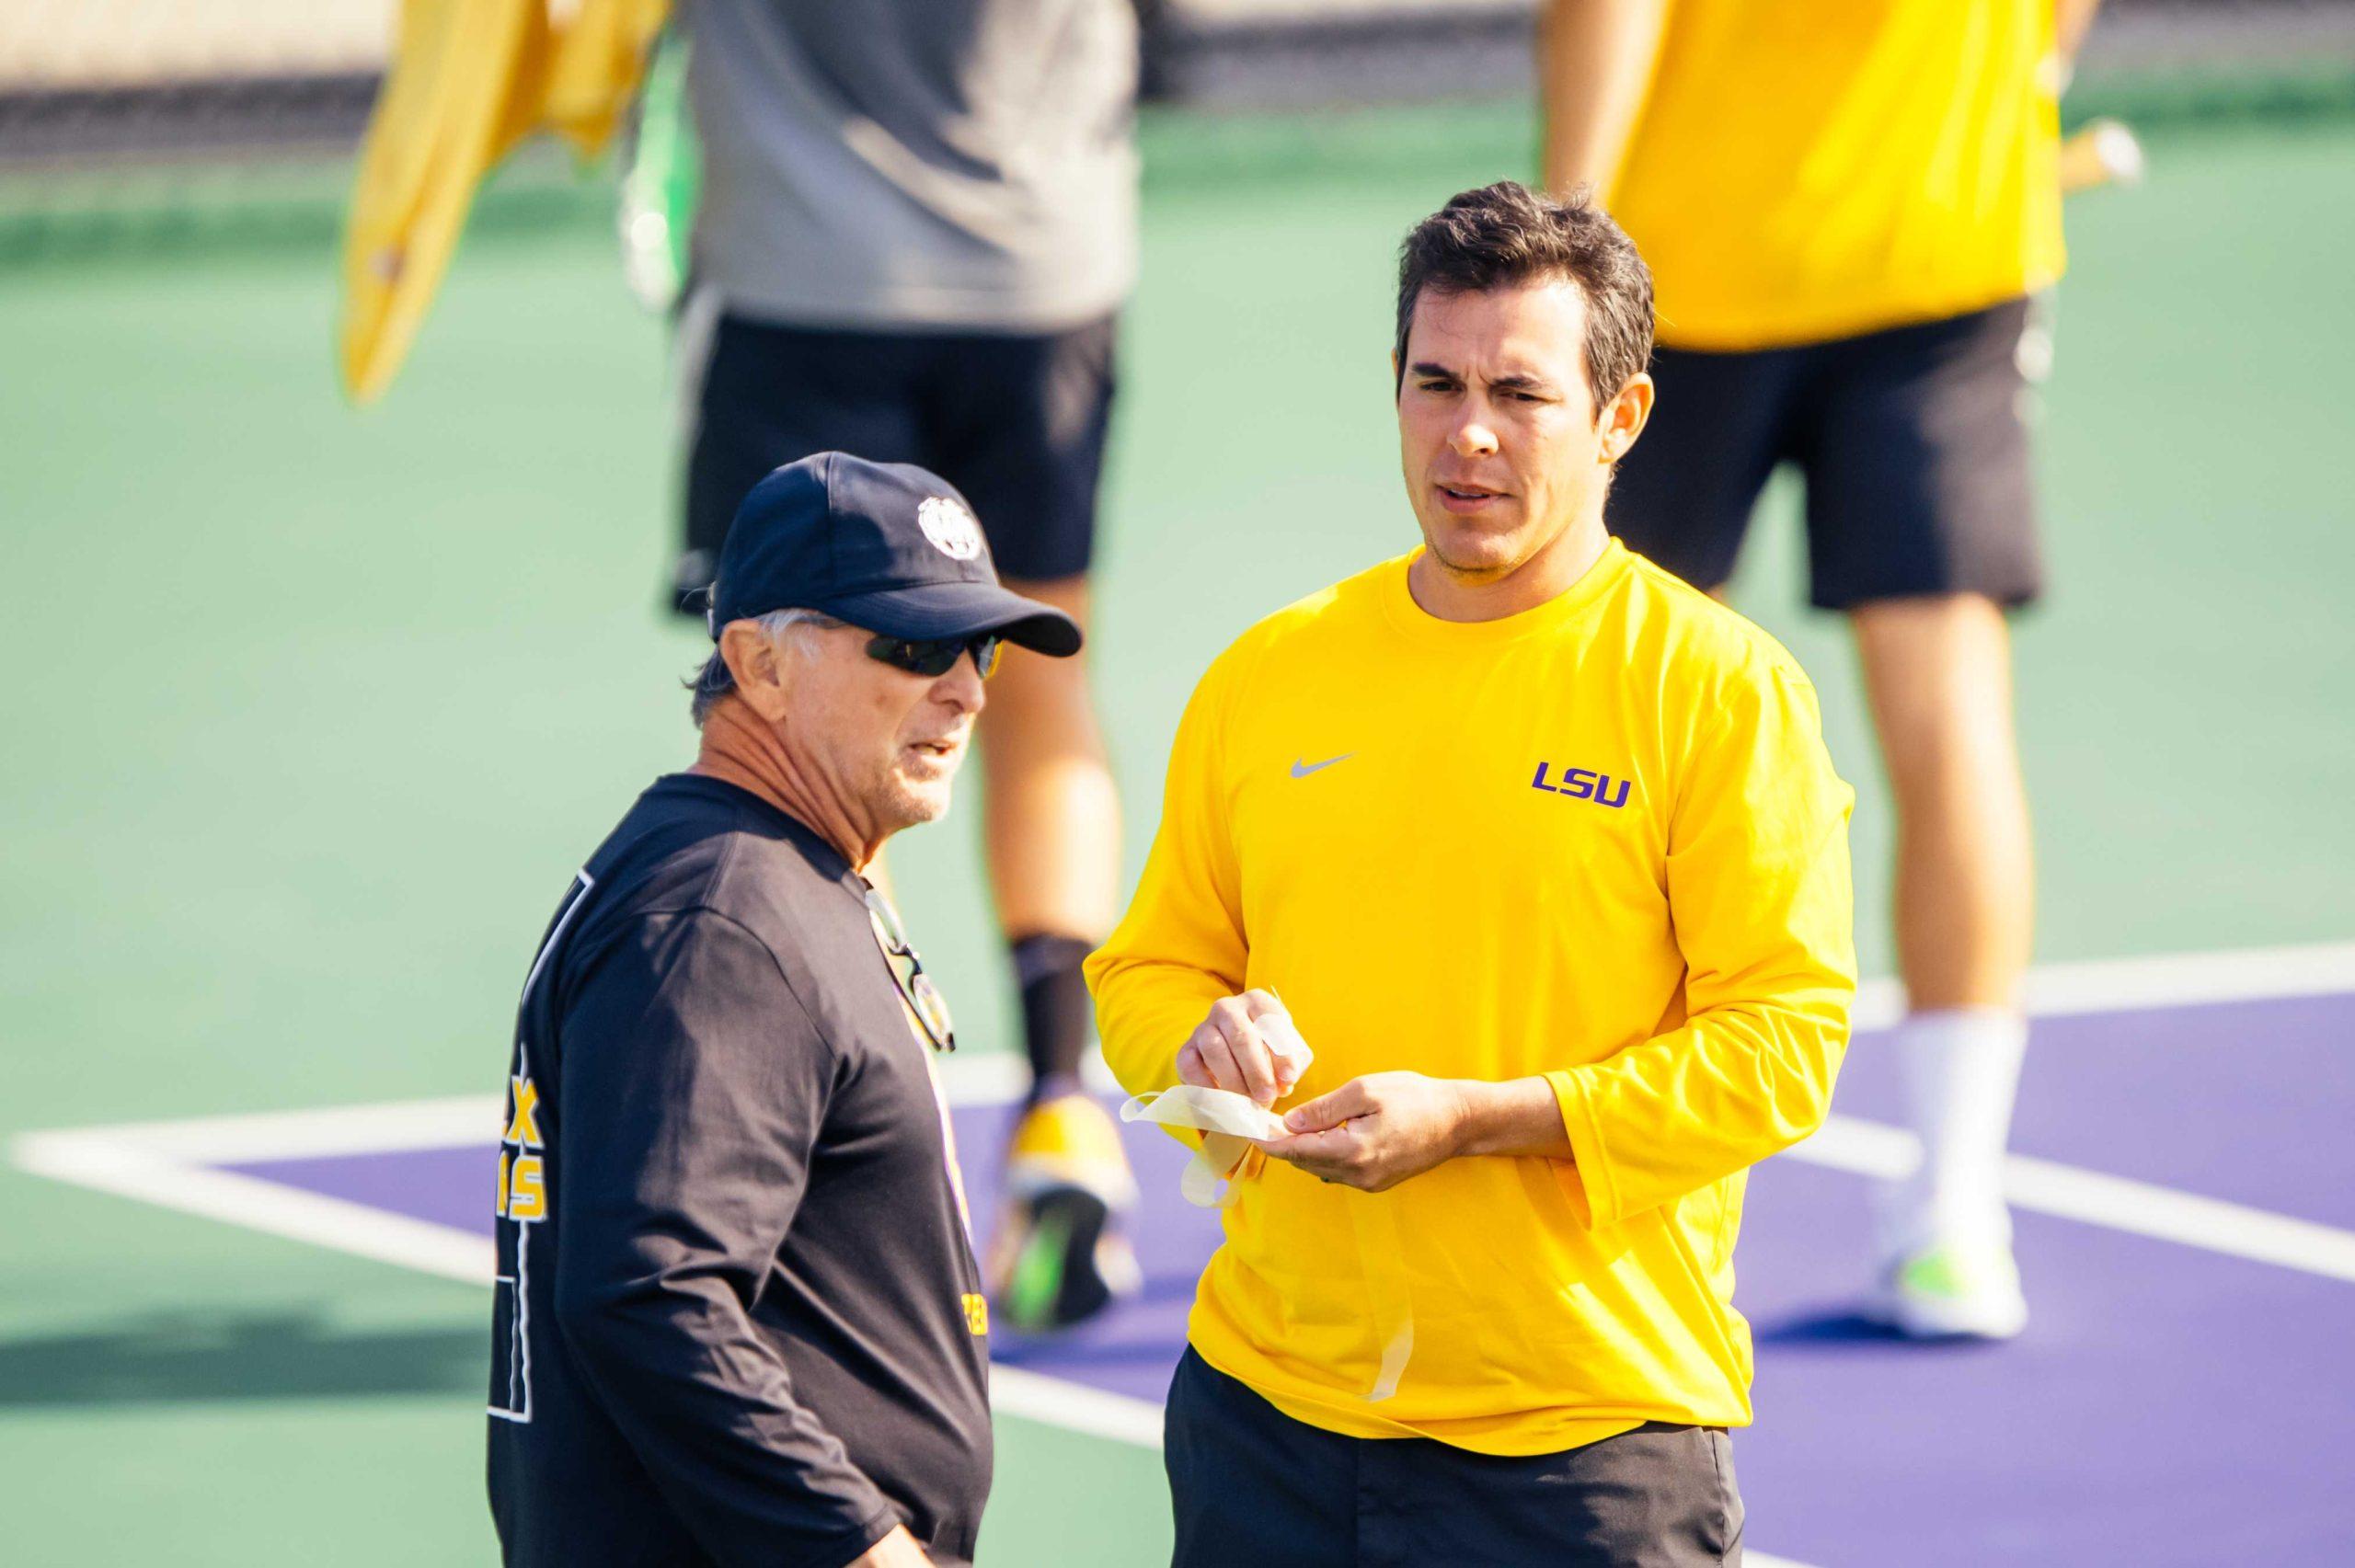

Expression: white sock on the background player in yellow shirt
xmin=1884 ymin=1008 xmax=2028 ymax=1253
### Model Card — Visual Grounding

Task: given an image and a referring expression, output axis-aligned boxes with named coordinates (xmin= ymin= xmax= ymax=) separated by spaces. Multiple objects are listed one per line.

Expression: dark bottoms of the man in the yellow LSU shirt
xmin=1161 ymin=1349 xmax=1742 ymax=1568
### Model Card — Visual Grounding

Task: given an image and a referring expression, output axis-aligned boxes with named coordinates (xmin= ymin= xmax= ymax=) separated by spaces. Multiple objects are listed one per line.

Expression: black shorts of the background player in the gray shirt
xmin=673 ymin=302 xmax=1116 ymax=614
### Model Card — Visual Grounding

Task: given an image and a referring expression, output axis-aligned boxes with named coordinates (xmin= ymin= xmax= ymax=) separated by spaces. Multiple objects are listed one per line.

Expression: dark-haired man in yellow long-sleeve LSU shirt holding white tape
xmin=1088 ymin=184 xmax=1855 ymax=1568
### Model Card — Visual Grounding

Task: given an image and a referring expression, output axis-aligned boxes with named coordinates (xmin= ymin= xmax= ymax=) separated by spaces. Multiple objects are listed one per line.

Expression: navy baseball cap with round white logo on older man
xmin=709 ymin=452 xmax=1081 ymax=659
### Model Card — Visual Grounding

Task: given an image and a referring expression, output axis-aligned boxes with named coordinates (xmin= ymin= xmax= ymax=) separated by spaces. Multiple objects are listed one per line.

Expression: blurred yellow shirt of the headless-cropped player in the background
xmin=1608 ymin=0 xmax=2063 ymax=350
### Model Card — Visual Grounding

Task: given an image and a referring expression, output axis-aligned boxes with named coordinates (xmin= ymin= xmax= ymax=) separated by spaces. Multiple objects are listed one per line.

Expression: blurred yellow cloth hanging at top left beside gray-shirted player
xmin=339 ymin=0 xmax=672 ymax=403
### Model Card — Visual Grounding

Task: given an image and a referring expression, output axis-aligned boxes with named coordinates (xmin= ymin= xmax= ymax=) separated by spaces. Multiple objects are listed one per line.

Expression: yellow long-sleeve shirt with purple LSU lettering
xmin=1088 ymin=542 xmax=1855 ymax=1455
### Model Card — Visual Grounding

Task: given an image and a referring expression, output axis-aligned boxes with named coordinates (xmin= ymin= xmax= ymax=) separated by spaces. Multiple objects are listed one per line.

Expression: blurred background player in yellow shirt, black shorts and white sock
xmin=1540 ymin=0 xmax=2094 ymax=1340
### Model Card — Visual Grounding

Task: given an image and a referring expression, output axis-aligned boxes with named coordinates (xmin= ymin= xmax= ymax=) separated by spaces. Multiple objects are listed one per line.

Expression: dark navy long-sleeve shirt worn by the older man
xmin=489 ymin=774 xmax=992 ymax=1568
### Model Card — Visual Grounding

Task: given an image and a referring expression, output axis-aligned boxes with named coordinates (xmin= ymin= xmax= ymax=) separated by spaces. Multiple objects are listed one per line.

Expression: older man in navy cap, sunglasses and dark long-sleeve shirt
xmin=489 ymin=452 xmax=1081 ymax=1568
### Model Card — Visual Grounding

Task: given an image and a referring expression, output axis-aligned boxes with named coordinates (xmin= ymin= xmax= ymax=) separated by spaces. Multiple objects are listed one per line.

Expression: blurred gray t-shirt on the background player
xmin=678 ymin=0 xmax=1137 ymax=332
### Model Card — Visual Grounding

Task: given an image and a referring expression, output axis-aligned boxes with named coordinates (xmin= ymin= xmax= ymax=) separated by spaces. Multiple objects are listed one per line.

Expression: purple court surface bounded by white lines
xmin=233 ymin=996 xmax=2355 ymax=1568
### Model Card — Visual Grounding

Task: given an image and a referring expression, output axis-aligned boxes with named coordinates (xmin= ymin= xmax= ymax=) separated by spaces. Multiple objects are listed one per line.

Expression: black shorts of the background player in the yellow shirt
xmin=1603 ymin=299 xmax=2051 ymax=610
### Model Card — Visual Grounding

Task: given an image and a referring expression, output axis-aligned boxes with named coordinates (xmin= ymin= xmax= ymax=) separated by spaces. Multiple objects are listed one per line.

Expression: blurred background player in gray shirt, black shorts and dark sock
xmin=673 ymin=0 xmax=1137 ymax=1330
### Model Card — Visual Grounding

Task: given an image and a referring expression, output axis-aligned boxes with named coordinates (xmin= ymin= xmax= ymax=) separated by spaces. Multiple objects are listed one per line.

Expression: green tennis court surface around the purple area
xmin=0 ymin=88 xmax=2355 ymax=1568
